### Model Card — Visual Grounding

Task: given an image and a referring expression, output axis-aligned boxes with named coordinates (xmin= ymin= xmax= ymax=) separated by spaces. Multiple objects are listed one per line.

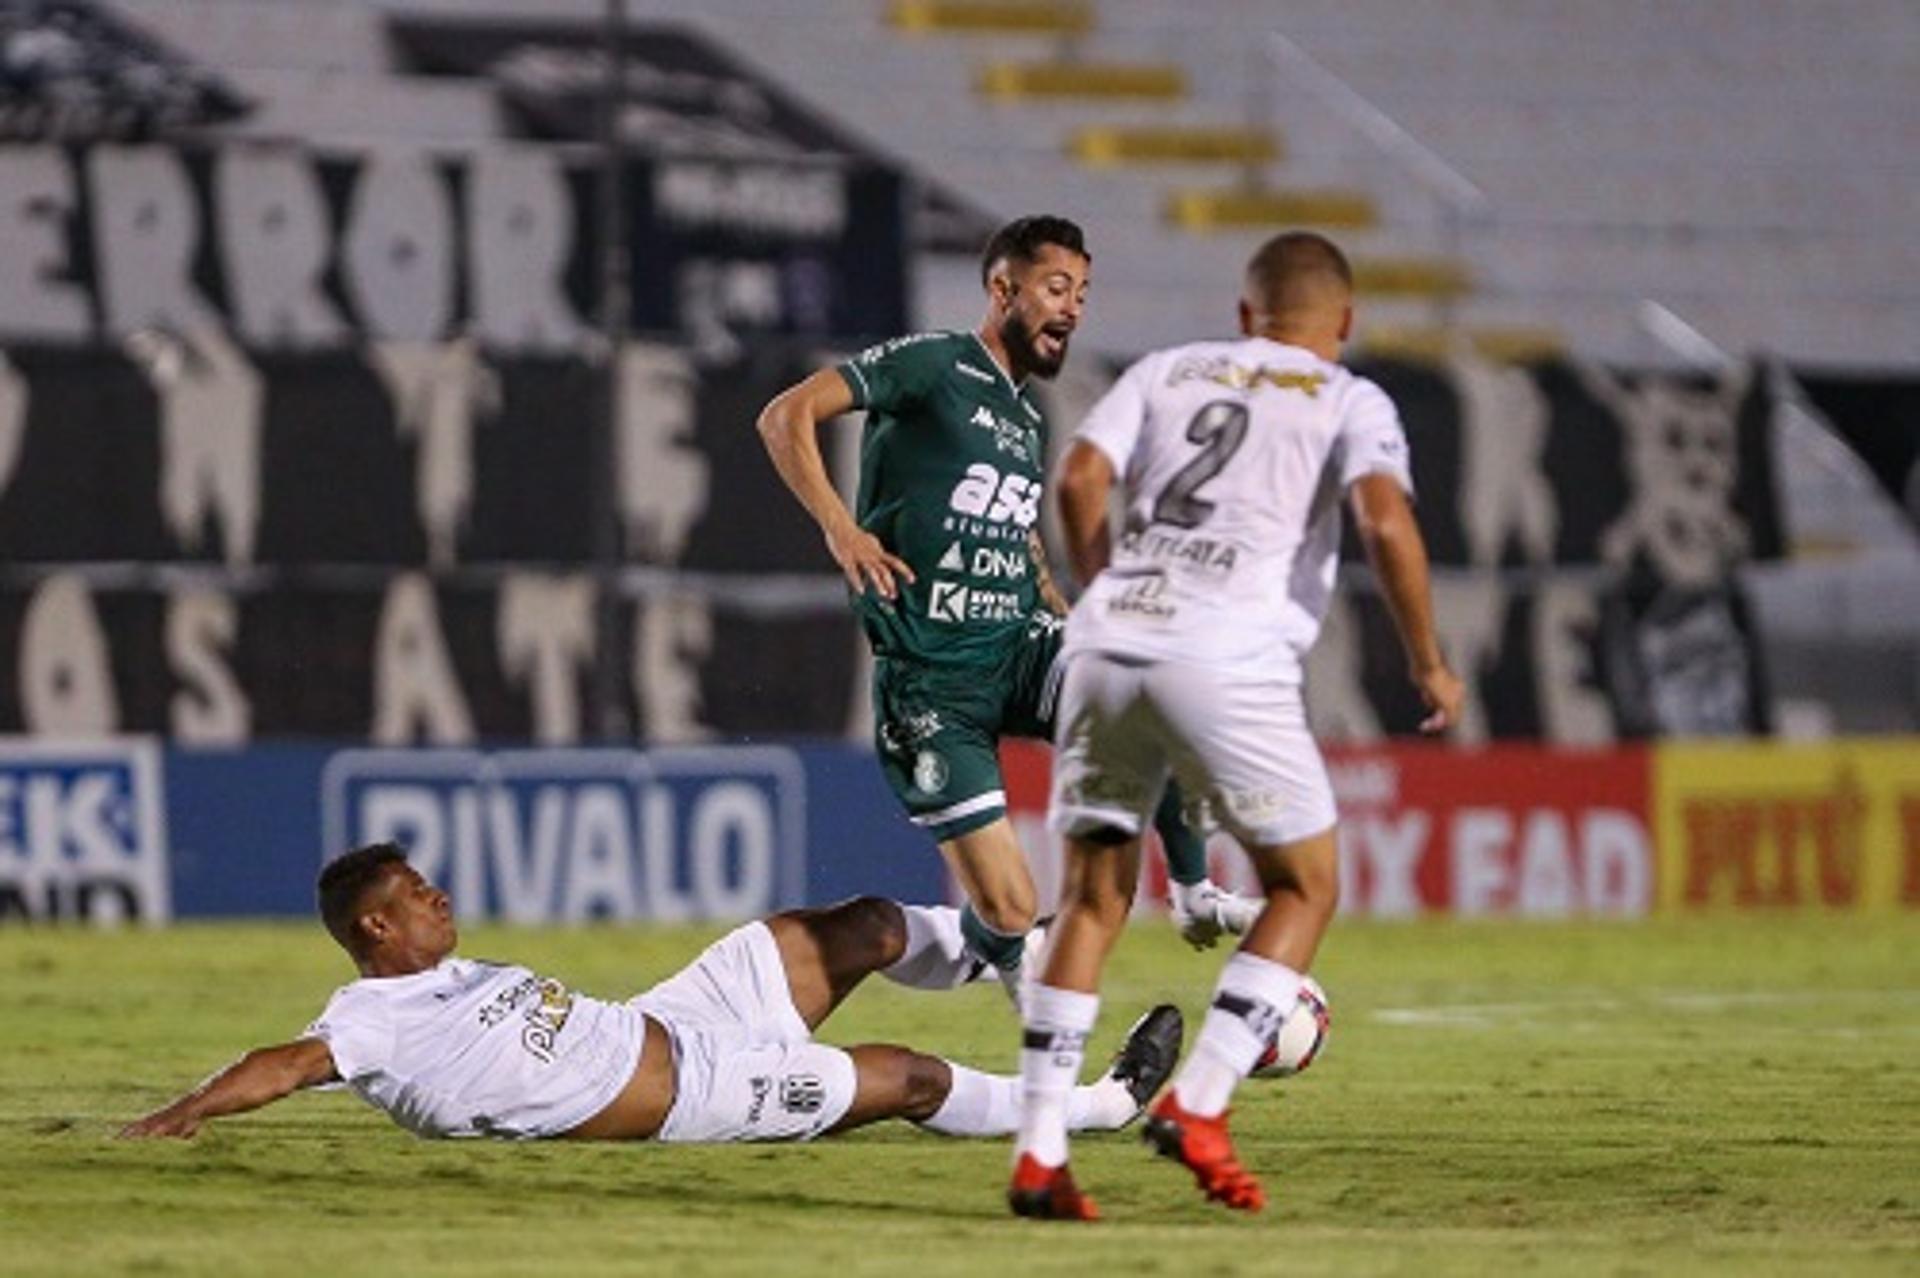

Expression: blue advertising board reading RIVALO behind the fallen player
xmin=0 ymin=739 xmax=947 ymax=923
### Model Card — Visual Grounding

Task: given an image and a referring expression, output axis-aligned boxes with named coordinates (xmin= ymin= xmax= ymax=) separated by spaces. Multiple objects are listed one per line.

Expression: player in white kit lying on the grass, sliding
xmin=121 ymin=842 xmax=1181 ymax=1142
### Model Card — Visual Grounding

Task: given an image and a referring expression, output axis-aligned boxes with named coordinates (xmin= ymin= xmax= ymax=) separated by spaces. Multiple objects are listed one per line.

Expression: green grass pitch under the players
xmin=0 ymin=917 xmax=1920 ymax=1278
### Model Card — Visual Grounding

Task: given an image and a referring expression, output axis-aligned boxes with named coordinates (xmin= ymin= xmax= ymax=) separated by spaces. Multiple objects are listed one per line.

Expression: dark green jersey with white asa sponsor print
xmin=839 ymin=332 xmax=1046 ymax=666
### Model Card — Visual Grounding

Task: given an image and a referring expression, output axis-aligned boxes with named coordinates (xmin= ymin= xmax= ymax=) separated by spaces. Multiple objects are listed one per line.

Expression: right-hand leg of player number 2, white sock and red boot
xmin=1142 ymin=829 xmax=1340 ymax=1211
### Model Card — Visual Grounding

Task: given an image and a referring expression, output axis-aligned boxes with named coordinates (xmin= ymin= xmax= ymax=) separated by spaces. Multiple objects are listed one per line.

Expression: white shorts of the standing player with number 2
xmin=1048 ymin=651 xmax=1334 ymax=846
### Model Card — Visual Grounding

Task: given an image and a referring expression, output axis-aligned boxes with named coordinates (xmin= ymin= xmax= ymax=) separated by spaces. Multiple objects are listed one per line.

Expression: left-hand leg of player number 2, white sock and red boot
xmin=1006 ymin=831 xmax=1140 ymax=1220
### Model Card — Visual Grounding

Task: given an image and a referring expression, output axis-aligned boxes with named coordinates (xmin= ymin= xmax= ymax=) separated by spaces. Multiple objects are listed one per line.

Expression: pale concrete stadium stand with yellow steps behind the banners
xmin=33 ymin=0 xmax=1920 ymax=729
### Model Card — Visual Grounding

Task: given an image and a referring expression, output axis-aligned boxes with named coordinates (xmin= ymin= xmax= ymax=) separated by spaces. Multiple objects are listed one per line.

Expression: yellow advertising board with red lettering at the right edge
xmin=1653 ymin=737 xmax=1920 ymax=913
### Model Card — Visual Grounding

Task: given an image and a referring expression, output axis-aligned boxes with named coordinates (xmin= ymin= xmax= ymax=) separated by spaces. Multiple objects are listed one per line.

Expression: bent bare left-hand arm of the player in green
xmin=758 ymin=360 xmax=914 ymax=599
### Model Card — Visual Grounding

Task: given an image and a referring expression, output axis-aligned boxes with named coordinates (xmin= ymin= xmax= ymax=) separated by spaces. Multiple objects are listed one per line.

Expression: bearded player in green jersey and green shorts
xmin=758 ymin=217 xmax=1260 ymax=988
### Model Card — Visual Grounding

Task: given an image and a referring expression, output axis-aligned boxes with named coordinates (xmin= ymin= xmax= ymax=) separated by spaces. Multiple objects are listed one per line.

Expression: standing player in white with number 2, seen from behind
xmin=1008 ymin=232 xmax=1461 ymax=1220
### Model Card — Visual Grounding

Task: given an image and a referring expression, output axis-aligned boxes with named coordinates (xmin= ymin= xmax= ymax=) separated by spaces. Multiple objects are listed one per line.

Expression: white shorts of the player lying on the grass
xmin=634 ymin=923 xmax=854 ymax=1142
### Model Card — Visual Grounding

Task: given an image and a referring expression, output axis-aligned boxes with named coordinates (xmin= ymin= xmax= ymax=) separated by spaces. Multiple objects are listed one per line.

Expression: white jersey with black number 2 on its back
xmin=1066 ymin=338 xmax=1413 ymax=683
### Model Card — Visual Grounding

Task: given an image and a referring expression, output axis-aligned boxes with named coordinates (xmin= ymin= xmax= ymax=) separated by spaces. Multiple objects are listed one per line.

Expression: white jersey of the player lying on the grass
xmin=307 ymin=958 xmax=645 ymax=1138
